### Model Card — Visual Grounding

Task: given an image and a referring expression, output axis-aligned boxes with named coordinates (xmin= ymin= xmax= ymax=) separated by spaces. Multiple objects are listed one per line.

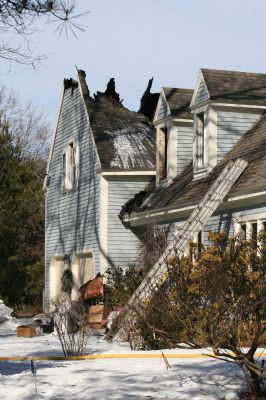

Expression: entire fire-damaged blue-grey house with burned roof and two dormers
xmin=45 ymin=69 xmax=266 ymax=307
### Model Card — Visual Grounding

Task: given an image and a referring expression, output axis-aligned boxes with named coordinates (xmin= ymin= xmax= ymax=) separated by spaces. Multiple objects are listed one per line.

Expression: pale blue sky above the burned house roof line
xmin=0 ymin=0 xmax=266 ymax=125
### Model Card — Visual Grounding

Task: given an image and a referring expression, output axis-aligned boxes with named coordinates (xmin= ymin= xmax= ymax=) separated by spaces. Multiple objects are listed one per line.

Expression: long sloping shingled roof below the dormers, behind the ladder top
xmin=121 ymin=113 xmax=266 ymax=216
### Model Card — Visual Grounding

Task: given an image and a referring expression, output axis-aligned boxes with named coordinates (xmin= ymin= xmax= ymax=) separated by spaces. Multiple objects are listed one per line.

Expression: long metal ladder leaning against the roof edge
xmin=114 ymin=158 xmax=248 ymax=339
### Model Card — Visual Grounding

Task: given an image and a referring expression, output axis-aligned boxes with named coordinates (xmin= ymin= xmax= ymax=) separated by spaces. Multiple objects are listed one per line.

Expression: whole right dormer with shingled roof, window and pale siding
xmin=190 ymin=69 xmax=266 ymax=179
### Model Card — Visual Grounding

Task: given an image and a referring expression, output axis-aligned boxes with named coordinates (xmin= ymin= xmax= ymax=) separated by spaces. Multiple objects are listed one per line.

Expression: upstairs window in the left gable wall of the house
xmin=62 ymin=142 xmax=79 ymax=190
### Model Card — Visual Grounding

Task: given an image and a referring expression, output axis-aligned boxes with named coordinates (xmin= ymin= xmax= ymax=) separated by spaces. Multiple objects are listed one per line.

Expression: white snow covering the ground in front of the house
xmin=0 ymin=332 xmax=245 ymax=400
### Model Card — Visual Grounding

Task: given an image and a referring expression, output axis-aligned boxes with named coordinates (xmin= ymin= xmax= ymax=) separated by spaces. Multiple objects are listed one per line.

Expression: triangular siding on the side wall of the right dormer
xmin=217 ymin=112 xmax=260 ymax=162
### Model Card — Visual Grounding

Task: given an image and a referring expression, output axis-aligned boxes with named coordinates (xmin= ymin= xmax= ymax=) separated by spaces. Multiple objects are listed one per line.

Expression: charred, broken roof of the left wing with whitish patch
xmin=78 ymin=71 xmax=156 ymax=170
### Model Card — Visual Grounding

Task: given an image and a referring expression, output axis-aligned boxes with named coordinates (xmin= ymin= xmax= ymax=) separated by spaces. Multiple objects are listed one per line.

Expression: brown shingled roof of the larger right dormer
xmin=201 ymin=68 xmax=266 ymax=106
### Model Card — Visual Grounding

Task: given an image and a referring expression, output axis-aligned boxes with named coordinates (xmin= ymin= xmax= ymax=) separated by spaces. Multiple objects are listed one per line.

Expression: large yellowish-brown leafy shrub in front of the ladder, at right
xmin=132 ymin=232 xmax=266 ymax=395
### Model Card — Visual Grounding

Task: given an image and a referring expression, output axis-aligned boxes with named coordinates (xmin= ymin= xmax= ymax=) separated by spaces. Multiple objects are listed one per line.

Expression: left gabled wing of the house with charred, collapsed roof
xmin=44 ymin=70 xmax=158 ymax=309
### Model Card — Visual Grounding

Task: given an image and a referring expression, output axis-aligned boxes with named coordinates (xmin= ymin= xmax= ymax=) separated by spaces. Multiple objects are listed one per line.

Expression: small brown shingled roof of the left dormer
xmin=163 ymin=87 xmax=193 ymax=119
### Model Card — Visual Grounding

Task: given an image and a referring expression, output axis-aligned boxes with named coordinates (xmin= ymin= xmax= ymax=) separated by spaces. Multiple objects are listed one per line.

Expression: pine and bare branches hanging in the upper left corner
xmin=0 ymin=0 xmax=88 ymax=69
